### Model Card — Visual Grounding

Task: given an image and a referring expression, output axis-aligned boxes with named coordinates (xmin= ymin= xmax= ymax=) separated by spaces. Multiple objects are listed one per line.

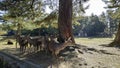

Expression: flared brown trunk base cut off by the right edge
xmin=109 ymin=23 xmax=120 ymax=47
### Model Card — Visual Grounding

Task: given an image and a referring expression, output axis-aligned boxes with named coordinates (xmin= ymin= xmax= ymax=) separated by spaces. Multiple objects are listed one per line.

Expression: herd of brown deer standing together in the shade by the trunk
xmin=16 ymin=35 xmax=72 ymax=57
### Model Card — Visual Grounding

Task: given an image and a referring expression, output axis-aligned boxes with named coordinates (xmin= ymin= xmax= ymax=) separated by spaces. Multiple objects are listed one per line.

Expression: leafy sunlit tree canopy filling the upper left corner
xmin=0 ymin=0 xmax=44 ymax=33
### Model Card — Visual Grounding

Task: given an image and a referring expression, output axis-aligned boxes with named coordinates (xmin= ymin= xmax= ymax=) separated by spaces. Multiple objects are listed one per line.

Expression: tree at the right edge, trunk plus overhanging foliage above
xmin=105 ymin=0 xmax=120 ymax=46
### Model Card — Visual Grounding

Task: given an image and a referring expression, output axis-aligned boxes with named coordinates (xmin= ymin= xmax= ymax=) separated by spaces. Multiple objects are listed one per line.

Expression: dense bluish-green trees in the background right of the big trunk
xmin=74 ymin=15 xmax=107 ymax=36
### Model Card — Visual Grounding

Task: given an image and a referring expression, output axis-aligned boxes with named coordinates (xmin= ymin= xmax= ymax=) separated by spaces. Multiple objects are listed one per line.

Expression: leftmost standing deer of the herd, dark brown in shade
xmin=16 ymin=35 xmax=28 ymax=52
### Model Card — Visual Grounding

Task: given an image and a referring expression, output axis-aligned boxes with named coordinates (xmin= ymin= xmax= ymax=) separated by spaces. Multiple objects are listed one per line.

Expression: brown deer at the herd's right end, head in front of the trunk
xmin=48 ymin=38 xmax=72 ymax=58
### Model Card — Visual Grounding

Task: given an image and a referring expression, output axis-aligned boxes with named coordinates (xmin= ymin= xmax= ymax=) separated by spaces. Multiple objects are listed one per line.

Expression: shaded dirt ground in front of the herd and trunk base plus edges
xmin=1 ymin=42 xmax=85 ymax=68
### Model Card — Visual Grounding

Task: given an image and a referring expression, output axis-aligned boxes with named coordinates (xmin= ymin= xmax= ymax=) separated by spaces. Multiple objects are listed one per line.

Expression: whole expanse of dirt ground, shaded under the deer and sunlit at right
xmin=0 ymin=38 xmax=120 ymax=68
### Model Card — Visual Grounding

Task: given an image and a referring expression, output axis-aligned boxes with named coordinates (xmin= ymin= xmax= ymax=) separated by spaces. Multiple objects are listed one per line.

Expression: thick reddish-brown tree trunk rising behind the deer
xmin=58 ymin=0 xmax=75 ymax=43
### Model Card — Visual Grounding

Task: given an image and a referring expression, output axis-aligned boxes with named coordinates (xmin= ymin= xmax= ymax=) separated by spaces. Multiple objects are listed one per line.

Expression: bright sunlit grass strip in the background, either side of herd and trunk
xmin=0 ymin=37 xmax=114 ymax=49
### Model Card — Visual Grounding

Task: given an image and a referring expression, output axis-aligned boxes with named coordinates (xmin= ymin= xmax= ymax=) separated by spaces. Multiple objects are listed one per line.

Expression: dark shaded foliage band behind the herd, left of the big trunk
xmin=21 ymin=26 xmax=58 ymax=36
